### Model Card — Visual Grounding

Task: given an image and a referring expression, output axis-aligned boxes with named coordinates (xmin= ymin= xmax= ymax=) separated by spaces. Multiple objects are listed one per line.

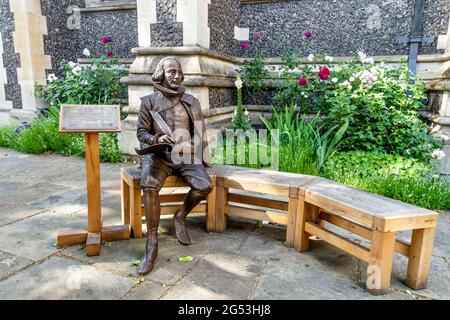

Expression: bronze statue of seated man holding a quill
xmin=137 ymin=57 xmax=212 ymax=274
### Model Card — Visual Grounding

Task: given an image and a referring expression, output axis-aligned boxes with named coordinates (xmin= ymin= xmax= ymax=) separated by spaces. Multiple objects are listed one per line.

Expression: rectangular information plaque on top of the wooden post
xmin=59 ymin=104 xmax=120 ymax=132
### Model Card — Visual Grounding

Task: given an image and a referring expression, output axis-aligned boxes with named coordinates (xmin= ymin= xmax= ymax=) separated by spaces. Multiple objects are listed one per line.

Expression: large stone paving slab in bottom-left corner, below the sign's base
xmin=0 ymin=257 xmax=133 ymax=300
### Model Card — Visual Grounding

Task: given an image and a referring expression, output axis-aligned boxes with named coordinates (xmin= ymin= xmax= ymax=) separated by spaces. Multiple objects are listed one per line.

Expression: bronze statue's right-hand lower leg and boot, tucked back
xmin=173 ymin=189 xmax=206 ymax=245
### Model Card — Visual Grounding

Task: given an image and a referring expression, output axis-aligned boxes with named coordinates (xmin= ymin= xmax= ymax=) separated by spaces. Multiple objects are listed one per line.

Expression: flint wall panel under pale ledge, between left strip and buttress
xmin=78 ymin=10 xmax=138 ymax=58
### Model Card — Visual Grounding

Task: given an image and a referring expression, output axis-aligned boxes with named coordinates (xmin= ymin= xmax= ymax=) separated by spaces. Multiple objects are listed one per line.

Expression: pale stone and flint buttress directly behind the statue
xmin=119 ymin=0 xmax=240 ymax=154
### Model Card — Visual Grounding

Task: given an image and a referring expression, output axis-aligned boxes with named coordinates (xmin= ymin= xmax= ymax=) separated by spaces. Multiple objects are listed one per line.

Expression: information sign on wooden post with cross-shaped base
xmin=57 ymin=104 xmax=130 ymax=256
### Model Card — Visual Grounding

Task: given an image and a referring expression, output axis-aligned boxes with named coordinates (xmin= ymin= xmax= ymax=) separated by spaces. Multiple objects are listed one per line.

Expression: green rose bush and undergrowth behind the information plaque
xmin=28 ymin=43 xmax=126 ymax=162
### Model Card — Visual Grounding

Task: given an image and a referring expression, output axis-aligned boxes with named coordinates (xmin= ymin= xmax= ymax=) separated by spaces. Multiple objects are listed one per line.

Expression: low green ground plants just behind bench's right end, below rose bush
xmin=324 ymin=151 xmax=450 ymax=210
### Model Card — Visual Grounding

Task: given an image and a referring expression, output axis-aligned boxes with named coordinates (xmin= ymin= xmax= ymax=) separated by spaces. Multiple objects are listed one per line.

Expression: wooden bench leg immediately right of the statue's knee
xmin=206 ymin=177 xmax=228 ymax=233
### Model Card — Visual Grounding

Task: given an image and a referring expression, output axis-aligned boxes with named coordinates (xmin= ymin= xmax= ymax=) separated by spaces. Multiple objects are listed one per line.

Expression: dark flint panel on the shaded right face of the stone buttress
xmin=208 ymin=0 xmax=240 ymax=56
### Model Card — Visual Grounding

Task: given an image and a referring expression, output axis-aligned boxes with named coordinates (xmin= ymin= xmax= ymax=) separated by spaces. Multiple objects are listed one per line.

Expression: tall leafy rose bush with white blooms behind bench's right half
xmin=326 ymin=66 xmax=442 ymax=159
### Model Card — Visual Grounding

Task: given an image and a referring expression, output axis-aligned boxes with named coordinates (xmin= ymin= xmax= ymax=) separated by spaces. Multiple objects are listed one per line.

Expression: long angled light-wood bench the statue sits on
xmin=121 ymin=166 xmax=437 ymax=294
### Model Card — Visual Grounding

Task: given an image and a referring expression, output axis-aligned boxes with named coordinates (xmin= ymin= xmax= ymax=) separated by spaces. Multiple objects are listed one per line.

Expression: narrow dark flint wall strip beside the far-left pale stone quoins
xmin=41 ymin=0 xmax=84 ymax=74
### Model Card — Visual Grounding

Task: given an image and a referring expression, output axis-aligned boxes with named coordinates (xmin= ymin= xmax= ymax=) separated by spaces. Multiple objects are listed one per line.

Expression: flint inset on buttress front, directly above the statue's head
xmin=151 ymin=0 xmax=183 ymax=47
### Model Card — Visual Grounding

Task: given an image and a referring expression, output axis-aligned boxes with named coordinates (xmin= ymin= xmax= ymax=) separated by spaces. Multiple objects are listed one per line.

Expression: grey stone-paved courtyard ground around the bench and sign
xmin=0 ymin=148 xmax=450 ymax=300
